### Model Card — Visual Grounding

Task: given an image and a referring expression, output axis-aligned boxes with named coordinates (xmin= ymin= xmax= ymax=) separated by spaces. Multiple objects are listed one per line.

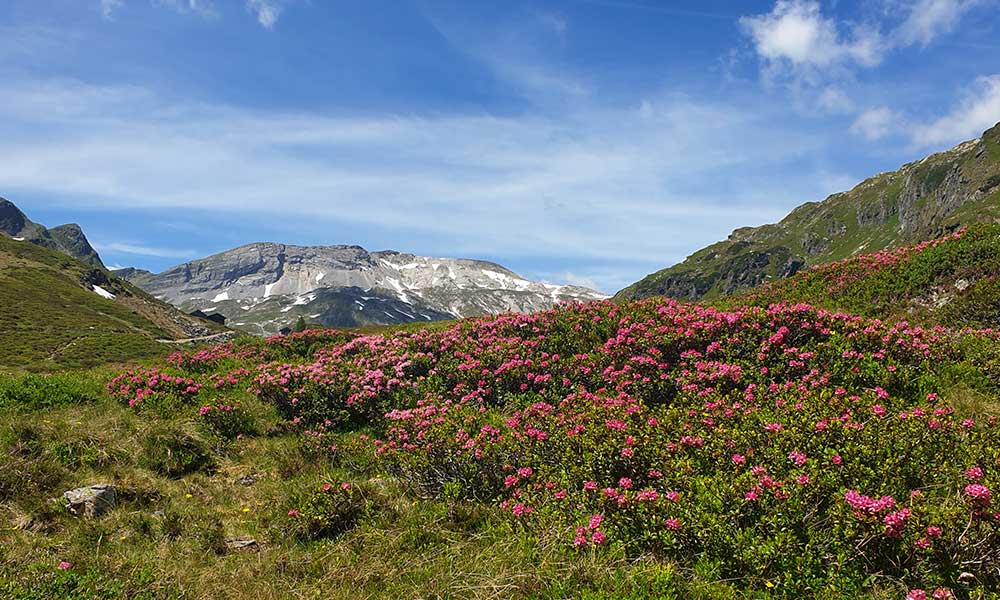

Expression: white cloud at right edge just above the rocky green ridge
xmin=913 ymin=74 xmax=1000 ymax=147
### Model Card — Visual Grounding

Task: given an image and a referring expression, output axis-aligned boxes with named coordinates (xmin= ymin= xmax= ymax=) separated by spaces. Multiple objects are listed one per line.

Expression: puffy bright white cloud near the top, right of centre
xmin=740 ymin=0 xmax=883 ymax=69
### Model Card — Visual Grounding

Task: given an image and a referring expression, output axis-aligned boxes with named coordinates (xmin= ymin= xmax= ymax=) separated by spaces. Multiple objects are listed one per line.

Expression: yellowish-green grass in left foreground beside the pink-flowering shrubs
xmin=0 ymin=375 xmax=772 ymax=600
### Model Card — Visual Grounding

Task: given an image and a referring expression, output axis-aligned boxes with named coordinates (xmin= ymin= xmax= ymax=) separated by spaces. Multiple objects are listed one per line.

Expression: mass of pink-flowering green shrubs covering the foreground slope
xmin=103 ymin=278 xmax=1000 ymax=596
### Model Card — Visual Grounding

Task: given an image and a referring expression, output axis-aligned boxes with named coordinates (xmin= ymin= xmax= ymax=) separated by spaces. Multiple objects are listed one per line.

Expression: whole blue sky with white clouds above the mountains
xmin=0 ymin=0 xmax=1000 ymax=293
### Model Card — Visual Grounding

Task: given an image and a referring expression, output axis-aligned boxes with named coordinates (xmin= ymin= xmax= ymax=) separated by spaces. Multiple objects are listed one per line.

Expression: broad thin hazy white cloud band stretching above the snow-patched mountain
xmin=0 ymin=80 xmax=853 ymax=291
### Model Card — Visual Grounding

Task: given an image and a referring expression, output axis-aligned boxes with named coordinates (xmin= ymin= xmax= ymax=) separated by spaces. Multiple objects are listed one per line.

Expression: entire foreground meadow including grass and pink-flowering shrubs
xmin=0 ymin=294 xmax=1000 ymax=599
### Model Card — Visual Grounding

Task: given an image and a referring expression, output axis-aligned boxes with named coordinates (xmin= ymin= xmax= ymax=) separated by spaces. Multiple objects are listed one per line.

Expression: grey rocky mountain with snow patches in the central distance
xmin=117 ymin=243 xmax=606 ymax=334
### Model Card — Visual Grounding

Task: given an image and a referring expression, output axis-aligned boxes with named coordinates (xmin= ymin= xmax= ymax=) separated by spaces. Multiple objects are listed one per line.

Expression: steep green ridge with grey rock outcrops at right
xmin=616 ymin=124 xmax=1000 ymax=300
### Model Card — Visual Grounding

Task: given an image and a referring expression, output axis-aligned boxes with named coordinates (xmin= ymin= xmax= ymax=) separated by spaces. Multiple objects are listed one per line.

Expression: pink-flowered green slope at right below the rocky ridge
xmin=715 ymin=224 xmax=1000 ymax=329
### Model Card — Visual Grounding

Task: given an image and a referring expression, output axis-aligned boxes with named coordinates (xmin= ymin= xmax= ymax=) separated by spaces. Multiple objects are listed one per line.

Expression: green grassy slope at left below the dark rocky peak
xmin=0 ymin=236 xmax=227 ymax=371
